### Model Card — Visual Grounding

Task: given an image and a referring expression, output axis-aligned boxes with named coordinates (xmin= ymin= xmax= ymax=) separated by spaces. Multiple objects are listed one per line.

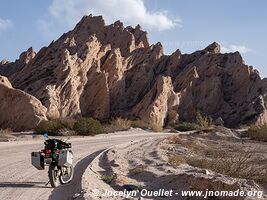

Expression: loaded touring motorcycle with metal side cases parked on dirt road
xmin=31 ymin=134 xmax=74 ymax=187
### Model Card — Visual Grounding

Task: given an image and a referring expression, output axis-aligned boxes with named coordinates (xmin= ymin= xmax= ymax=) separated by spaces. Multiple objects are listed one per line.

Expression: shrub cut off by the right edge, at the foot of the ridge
xmin=247 ymin=124 xmax=267 ymax=142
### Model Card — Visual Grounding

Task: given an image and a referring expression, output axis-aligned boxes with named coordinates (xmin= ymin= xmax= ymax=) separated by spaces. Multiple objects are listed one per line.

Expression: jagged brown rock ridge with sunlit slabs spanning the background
xmin=0 ymin=16 xmax=267 ymax=129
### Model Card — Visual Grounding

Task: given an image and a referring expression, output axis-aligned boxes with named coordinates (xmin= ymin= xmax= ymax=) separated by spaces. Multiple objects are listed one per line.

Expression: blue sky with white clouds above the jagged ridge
xmin=0 ymin=0 xmax=267 ymax=77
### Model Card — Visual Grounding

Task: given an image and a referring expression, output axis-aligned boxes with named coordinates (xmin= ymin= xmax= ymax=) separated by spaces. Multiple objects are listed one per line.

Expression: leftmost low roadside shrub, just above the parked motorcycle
xmin=34 ymin=119 xmax=64 ymax=135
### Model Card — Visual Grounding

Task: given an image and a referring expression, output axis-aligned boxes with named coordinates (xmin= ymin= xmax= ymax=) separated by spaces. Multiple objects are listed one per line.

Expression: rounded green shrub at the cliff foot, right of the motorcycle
xmin=73 ymin=118 xmax=104 ymax=135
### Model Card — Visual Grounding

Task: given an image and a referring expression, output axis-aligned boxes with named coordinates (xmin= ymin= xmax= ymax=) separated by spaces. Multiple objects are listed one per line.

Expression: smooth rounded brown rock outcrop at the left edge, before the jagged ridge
xmin=0 ymin=76 xmax=47 ymax=131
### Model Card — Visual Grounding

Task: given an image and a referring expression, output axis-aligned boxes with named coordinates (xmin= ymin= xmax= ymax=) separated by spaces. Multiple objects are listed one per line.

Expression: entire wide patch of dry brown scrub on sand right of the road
xmin=167 ymin=135 xmax=267 ymax=182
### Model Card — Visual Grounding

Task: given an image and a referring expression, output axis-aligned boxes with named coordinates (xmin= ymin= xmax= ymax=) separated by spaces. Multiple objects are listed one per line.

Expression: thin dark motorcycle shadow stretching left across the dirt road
xmin=0 ymin=182 xmax=51 ymax=188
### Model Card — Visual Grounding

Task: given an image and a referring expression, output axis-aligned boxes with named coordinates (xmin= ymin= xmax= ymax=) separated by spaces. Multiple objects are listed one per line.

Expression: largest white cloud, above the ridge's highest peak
xmin=38 ymin=0 xmax=181 ymax=34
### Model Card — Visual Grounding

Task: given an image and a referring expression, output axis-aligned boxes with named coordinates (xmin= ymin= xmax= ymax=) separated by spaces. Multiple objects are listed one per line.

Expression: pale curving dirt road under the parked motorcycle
xmin=0 ymin=130 xmax=171 ymax=200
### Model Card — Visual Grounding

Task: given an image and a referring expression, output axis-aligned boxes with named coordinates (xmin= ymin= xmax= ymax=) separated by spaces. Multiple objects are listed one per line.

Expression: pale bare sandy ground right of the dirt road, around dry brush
xmin=82 ymin=129 xmax=267 ymax=200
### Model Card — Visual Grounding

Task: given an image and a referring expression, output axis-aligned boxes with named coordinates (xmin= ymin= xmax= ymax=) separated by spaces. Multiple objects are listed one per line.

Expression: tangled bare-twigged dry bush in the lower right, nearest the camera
xmin=187 ymin=149 xmax=267 ymax=182
